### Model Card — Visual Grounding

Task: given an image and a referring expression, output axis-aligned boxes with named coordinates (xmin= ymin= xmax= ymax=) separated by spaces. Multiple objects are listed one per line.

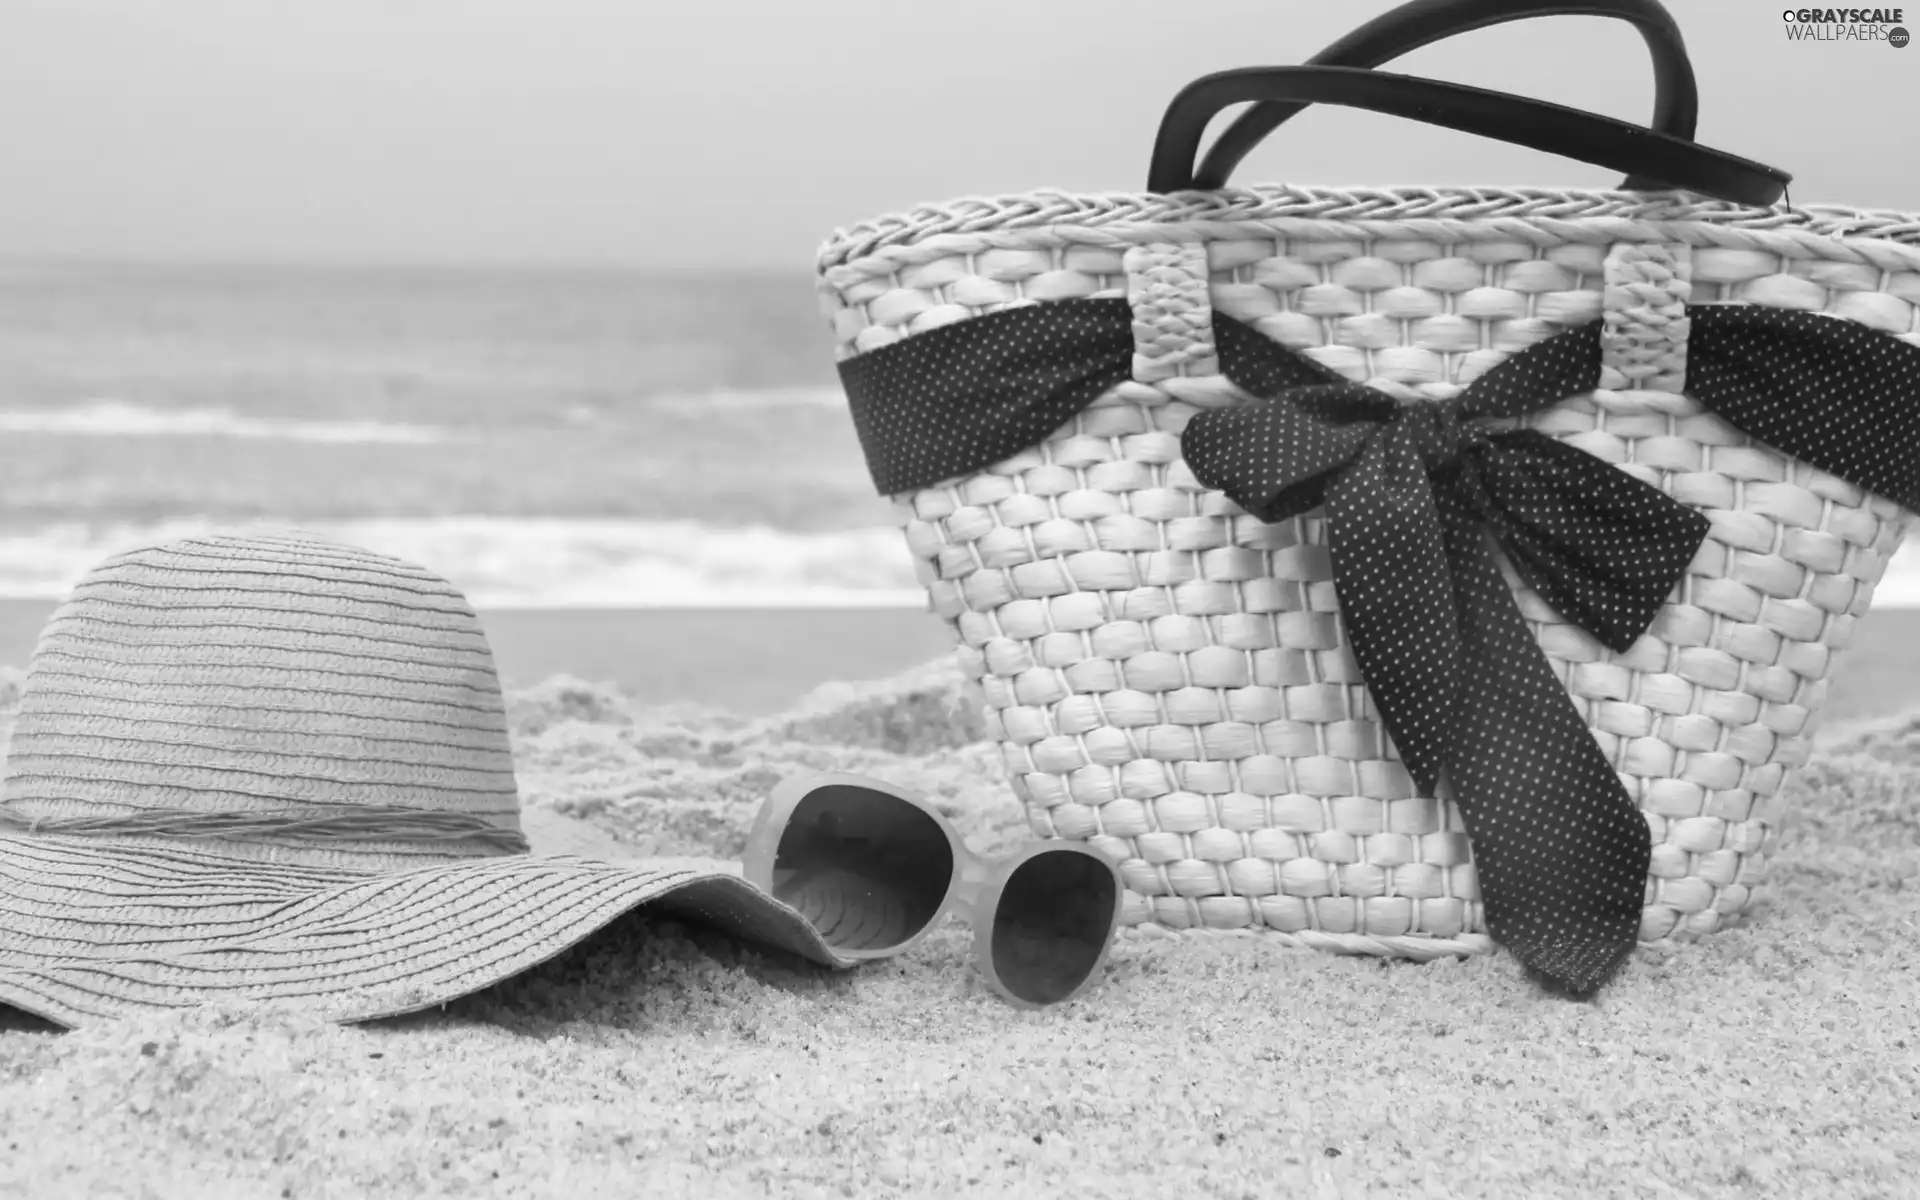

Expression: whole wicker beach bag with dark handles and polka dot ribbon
xmin=818 ymin=0 xmax=1920 ymax=995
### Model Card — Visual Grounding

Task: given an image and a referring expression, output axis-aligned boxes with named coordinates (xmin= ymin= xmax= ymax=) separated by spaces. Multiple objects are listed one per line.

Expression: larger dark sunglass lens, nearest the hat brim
xmin=774 ymin=783 xmax=954 ymax=954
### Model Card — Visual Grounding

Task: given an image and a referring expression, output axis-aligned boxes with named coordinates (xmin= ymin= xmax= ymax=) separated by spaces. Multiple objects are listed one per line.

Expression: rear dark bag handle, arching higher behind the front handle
xmin=1192 ymin=0 xmax=1699 ymax=190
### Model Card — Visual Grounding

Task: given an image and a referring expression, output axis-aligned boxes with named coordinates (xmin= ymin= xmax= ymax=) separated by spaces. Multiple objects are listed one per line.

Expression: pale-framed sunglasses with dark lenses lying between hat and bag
xmin=743 ymin=774 xmax=1123 ymax=1008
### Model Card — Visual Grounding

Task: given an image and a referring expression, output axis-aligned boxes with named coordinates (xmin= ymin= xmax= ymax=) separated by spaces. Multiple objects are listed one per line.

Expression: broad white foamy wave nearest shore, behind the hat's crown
xmin=0 ymin=516 xmax=925 ymax=609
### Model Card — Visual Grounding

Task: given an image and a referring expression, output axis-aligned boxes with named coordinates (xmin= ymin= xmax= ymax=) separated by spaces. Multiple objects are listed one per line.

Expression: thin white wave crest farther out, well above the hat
xmin=0 ymin=399 xmax=457 ymax=444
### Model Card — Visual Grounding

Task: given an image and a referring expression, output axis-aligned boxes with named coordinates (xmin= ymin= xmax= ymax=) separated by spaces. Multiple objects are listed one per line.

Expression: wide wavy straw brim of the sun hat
xmin=0 ymin=835 xmax=852 ymax=1027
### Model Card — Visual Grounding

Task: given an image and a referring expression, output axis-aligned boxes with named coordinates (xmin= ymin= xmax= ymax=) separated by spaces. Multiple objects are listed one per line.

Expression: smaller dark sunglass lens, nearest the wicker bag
xmin=993 ymin=849 xmax=1119 ymax=1004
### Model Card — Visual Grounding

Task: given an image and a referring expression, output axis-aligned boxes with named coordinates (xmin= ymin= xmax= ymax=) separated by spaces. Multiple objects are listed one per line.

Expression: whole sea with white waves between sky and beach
xmin=0 ymin=255 xmax=1920 ymax=609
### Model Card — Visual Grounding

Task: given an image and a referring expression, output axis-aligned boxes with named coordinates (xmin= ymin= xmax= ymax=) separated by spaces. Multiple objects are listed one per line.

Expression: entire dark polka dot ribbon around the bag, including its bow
xmin=841 ymin=300 xmax=1920 ymax=996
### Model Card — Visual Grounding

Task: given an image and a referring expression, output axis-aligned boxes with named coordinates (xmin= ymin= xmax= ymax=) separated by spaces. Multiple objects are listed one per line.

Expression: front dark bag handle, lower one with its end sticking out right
xmin=1146 ymin=67 xmax=1793 ymax=205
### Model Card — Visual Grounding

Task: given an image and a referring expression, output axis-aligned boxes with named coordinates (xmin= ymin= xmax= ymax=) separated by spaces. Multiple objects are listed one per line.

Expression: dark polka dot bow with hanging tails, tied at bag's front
xmin=1181 ymin=316 xmax=1709 ymax=995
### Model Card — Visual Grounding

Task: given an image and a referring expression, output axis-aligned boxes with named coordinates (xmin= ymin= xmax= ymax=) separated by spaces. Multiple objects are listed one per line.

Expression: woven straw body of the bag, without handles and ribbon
xmin=818 ymin=0 xmax=1920 ymax=958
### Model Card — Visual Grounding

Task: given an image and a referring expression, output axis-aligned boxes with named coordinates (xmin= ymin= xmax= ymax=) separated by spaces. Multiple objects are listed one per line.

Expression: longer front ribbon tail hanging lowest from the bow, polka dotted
xmin=1434 ymin=478 xmax=1651 ymax=998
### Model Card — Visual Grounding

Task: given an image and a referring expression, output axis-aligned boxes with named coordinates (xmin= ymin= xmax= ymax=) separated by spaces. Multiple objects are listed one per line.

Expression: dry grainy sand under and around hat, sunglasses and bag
xmin=0 ymin=668 xmax=1920 ymax=1198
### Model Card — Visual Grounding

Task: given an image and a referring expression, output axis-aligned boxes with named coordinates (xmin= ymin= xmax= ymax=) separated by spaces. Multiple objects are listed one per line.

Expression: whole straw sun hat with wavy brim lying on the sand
xmin=0 ymin=534 xmax=851 ymax=1025
